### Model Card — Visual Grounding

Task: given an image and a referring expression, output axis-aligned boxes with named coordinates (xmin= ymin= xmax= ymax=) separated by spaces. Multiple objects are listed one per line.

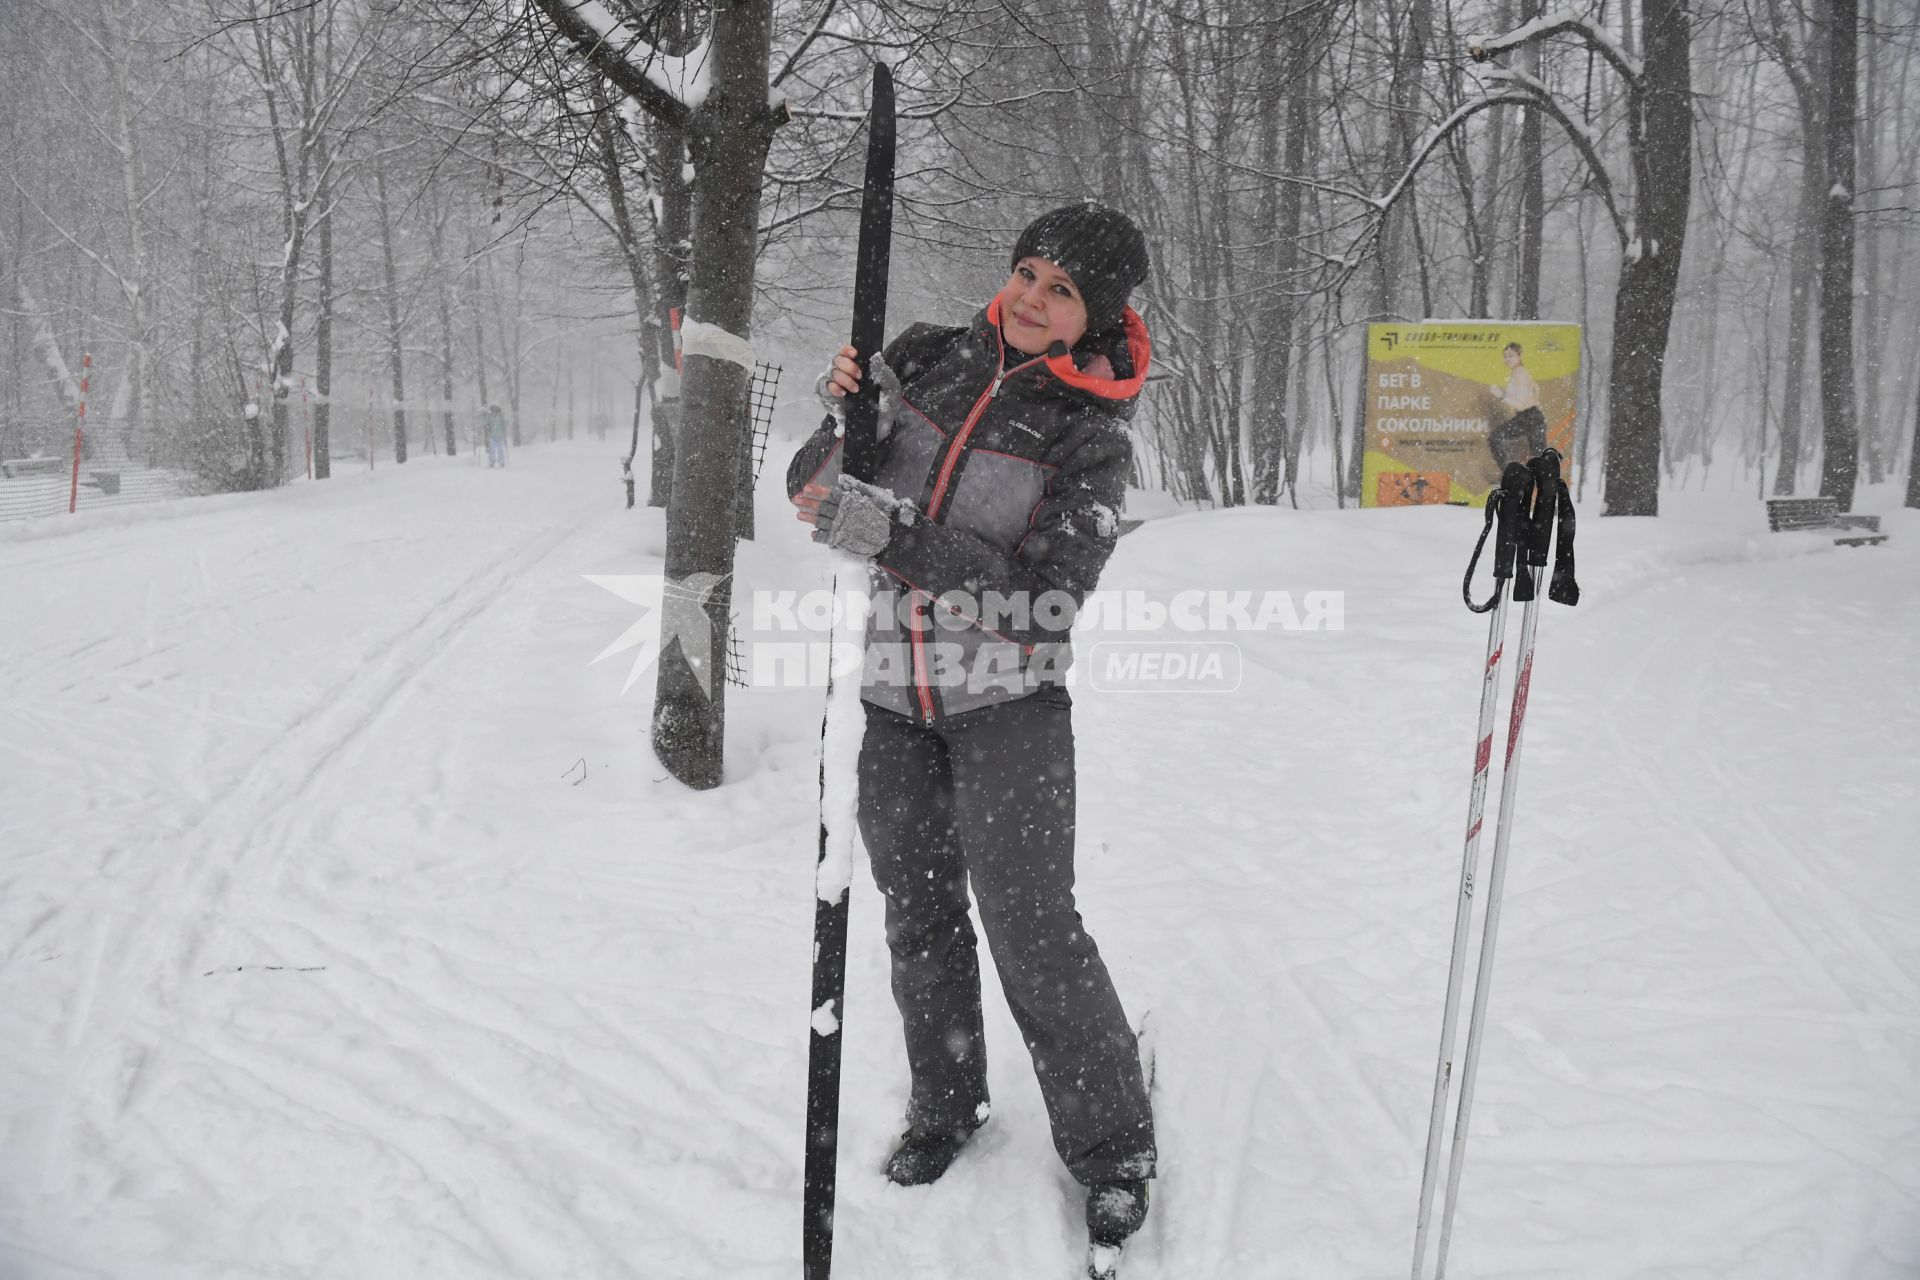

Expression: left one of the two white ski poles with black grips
xmin=1413 ymin=462 xmax=1532 ymax=1280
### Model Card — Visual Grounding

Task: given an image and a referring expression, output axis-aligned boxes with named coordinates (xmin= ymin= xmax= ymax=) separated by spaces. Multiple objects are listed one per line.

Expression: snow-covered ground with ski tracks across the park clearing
xmin=0 ymin=443 xmax=1920 ymax=1280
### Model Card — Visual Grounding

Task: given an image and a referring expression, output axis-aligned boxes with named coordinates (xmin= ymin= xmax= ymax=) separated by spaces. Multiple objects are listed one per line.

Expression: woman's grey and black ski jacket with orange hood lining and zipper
xmin=787 ymin=299 xmax=1152 ymax=723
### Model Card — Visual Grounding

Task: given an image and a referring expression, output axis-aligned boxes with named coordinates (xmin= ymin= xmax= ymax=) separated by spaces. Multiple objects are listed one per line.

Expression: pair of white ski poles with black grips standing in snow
xmin=1413 ymin=449 xmax=1580 ymax=1280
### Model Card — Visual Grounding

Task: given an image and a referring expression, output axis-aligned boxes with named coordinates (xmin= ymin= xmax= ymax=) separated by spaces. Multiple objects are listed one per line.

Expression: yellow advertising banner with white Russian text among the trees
xmin=1359 ymin=320 xmax=1580 ymax=507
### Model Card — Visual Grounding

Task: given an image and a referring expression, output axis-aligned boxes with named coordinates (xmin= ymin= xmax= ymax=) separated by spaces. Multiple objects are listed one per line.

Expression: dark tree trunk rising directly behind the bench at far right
xmin=1820 ymin=0 xmax=1860 ymax=510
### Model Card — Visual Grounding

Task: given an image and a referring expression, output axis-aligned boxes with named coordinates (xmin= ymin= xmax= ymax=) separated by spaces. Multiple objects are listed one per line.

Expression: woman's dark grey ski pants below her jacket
xmin=860 ymin=689 xmax=1154 ymax=1184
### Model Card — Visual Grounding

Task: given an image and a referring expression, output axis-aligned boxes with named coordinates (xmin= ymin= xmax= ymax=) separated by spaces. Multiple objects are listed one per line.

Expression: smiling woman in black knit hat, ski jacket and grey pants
xmin=787 ymin=203 xmax=1156 ymax=1245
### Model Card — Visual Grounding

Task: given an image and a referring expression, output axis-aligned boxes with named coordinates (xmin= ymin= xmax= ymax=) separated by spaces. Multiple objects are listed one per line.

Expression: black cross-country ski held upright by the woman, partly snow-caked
xmin=801 ymin=63 xmax=893 ymax=1280
